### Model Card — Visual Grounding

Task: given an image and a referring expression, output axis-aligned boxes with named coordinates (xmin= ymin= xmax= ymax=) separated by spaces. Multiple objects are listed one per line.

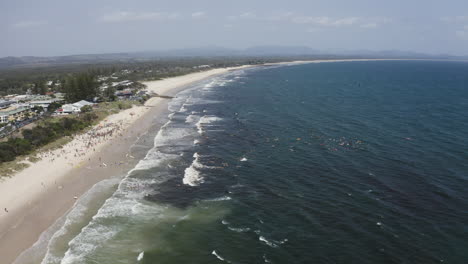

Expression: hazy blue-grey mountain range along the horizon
xmin=0 ymin=46 xmax=468 ymax=69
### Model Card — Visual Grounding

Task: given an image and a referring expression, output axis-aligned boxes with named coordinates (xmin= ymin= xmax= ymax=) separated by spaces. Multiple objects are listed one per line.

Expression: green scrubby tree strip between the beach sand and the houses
xmin=0 ymin=112 xmax=98 ymax=162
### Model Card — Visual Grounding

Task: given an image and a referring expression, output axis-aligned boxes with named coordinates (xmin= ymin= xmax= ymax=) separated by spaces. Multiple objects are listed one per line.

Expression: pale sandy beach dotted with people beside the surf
xmin=0 ymin=67 xmax=249 ymax=264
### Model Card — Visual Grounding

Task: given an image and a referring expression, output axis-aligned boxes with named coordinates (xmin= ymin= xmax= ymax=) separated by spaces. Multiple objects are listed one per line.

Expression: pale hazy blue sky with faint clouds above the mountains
xmin=0 ymin=0 xmax=468 ymax=57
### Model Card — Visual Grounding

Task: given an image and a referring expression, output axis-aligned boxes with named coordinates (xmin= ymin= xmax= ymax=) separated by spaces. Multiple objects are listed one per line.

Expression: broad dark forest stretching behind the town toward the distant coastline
xmin=0 ymin=57 xmax=294 ymax=97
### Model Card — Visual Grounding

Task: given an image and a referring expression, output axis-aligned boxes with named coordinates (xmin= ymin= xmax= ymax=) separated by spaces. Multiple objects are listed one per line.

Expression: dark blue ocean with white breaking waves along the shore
xmin=31 ymin=61 xmax=468 ymax=264
